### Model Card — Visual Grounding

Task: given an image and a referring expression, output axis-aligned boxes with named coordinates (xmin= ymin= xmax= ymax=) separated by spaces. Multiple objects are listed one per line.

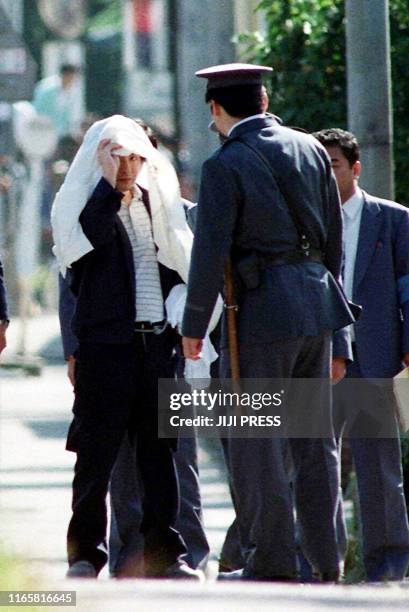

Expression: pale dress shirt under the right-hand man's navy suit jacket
xmin=342 ymin=187 xmax=364 ymax=340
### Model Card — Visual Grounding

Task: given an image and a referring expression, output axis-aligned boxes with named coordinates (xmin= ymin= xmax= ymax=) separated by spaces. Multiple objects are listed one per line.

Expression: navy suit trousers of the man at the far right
xmin=334 ymin=355 xmax=409 ymax=580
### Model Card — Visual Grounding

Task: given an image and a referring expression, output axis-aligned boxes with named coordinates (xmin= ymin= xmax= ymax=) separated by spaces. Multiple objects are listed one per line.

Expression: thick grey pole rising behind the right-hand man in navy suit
xmin=346 ymin=0 xmax=394 ymax=200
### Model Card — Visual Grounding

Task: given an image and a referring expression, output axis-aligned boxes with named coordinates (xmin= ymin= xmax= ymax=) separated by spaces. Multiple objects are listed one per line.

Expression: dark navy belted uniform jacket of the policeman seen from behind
xmin=183 ymin=117 xmax=353 ymax=344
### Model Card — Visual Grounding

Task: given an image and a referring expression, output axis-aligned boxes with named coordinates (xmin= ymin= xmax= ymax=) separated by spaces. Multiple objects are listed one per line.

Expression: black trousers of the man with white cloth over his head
xmin=67 ymin=330 xmax=186 ymax=576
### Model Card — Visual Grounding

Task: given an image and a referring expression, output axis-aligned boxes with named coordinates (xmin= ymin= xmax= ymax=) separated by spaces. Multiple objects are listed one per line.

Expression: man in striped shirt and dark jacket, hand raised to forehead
xmin=62 ymin=131 xmax=200 ymax=579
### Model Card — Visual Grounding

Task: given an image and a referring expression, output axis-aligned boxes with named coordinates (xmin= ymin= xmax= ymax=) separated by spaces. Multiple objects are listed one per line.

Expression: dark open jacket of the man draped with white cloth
xmin=71 ymin=178 xmax=182 ymax=344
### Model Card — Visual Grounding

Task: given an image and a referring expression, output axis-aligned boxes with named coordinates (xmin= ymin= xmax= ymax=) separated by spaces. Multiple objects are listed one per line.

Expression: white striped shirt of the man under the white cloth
xmin=118 ymin=189 xmax=165 ymax=323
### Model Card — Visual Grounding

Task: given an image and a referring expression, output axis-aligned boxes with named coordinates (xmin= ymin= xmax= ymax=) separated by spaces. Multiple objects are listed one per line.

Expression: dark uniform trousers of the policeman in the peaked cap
xmin=222 ymin=333 xmax=340 ymax=578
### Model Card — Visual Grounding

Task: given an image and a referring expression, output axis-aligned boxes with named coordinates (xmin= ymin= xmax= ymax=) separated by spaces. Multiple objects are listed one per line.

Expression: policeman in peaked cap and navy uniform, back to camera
xmin=182 ymin=64 xmax=353 ymax=581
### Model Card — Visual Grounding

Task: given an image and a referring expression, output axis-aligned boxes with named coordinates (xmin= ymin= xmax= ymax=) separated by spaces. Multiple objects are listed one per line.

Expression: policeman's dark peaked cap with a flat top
xmin=196 ymin=63 xmax=273 ymax=91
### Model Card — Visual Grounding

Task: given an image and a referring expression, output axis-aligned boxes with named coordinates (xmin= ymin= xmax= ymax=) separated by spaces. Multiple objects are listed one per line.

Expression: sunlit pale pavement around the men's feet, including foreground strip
xmin=0 ymin=315 xmax=409 ymax=612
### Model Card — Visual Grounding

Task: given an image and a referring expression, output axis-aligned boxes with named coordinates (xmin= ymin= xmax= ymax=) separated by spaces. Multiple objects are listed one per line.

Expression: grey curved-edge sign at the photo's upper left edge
xmin=0 ymin=5 xmax=36 ymax=102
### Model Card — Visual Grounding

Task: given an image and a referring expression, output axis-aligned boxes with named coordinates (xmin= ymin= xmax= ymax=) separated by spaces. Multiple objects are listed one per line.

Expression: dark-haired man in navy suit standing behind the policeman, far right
xmin=315 ymin=129 xmax=409 ymax=581
